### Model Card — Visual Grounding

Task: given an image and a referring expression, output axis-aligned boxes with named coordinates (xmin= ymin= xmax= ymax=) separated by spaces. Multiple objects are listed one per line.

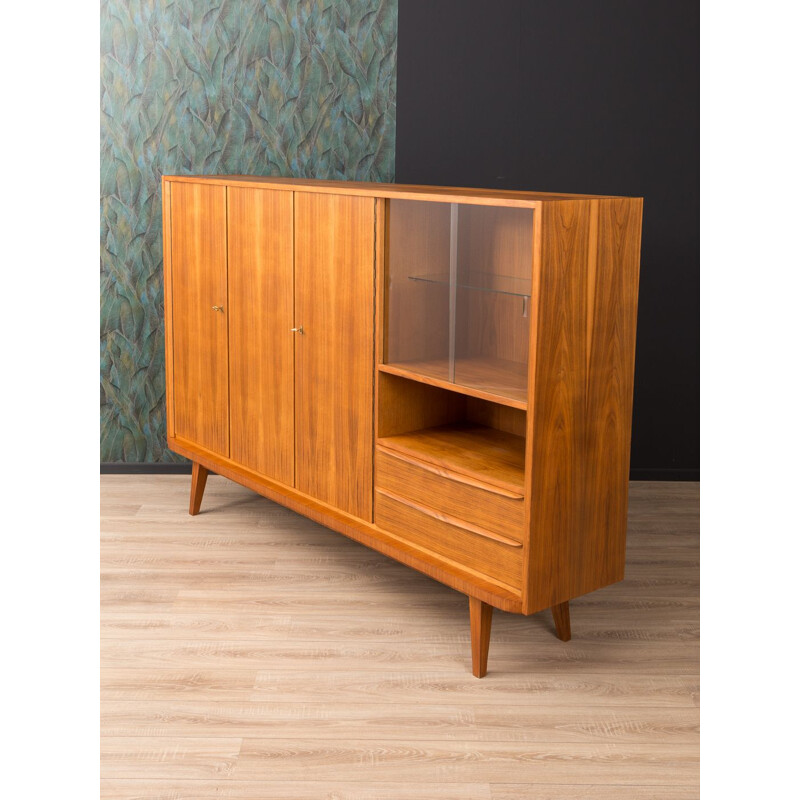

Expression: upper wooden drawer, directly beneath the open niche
xmin=375 ymin=448 xmax=525 ymax=542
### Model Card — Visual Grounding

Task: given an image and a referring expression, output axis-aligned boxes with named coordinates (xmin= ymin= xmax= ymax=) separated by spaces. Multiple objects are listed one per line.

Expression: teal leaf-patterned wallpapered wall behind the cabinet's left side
xmin=100 ymin=0 xmax=398 ymax=462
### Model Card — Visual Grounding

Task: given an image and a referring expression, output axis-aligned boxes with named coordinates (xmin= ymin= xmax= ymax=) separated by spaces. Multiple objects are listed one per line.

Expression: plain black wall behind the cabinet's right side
xmin=396 ymin=0 xmax=700 ymax=479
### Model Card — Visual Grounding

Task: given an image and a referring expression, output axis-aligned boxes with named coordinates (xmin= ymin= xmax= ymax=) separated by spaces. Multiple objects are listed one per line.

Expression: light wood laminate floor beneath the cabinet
xmin=101 ymin=475 xmax=699 ymax=800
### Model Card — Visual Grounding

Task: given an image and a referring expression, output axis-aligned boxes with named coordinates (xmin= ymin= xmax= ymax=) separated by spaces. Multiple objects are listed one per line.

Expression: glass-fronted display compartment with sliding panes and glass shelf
xmin=384 ymin=200 xmax=533 ymax=402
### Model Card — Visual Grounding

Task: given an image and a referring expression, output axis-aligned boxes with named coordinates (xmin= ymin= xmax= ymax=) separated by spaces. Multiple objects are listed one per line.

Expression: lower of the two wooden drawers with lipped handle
xmin=375 ymin=489 xmax=522 ymax=589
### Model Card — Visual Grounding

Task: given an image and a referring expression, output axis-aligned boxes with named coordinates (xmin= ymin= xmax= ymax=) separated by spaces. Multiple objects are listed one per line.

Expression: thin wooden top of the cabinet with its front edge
xmin=163 ymin=175 xmax=636 ymax=207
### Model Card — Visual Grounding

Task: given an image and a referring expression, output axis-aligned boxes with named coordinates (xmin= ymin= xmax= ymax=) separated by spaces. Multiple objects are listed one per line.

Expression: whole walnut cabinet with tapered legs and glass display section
xmin=162 ymin=176 xmax=642 ymax=677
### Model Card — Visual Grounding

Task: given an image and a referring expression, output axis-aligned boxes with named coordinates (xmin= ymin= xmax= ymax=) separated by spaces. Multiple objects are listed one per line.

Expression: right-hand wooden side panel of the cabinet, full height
xmin=526 ymin=198 xmax=641 ymax=612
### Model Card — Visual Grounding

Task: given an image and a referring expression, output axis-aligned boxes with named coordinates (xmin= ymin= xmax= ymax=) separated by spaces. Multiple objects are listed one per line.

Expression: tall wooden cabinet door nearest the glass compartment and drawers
xmin=294 ymin=192 xmax=375 ymax=520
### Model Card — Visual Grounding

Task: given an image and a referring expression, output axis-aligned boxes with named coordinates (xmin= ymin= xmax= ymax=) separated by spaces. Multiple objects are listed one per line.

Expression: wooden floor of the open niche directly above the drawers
xmin=377 ymin=422 xmax=525 ymax=495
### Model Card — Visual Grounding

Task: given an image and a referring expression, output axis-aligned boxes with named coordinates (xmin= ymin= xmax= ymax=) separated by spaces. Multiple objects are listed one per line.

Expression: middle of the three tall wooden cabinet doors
xmin=228 ymin=186 xmax=295 ymax=486
